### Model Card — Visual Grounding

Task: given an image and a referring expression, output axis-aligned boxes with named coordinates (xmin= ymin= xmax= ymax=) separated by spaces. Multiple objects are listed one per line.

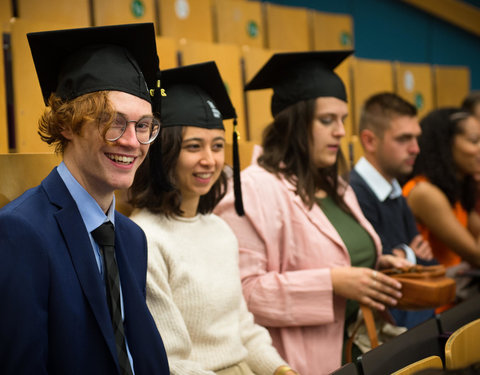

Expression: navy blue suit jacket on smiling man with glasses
xmin=0 ymin=169 xmax=169 ymax=375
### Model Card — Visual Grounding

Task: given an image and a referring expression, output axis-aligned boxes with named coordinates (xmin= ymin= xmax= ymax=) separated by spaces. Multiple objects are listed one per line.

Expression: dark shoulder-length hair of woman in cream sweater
xmin=128 ymin=126 xmax=227 ymax=217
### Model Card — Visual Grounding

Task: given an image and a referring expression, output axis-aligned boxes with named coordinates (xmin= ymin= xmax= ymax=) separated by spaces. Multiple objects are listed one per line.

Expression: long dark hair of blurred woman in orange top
xmin=412 ymin=107 xmax=475 ymax=212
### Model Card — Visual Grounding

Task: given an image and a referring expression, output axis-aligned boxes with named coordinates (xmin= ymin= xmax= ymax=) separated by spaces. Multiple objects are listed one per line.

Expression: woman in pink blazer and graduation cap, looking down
xmin=216 ymin=51 xmax=403 ymax=375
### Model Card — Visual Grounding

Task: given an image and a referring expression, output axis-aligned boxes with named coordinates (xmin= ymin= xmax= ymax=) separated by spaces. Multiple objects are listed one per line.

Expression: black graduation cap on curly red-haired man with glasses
xmin=27 ymin=23 xmax=160 ymax=111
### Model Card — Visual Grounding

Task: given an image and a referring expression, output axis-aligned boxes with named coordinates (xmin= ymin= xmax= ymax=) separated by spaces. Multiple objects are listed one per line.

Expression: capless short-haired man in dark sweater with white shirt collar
xmin=350 ymin=92 xmax=433 ymax=328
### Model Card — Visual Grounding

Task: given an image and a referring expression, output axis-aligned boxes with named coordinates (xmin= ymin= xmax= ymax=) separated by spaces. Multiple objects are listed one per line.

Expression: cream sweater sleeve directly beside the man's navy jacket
xmin=143 ymin=226 xmax=215 ymax=375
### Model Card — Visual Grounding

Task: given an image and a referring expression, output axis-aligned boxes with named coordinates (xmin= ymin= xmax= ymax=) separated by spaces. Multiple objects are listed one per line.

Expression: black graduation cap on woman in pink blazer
xmin=245 ymin=50 xmax=353 ymax=116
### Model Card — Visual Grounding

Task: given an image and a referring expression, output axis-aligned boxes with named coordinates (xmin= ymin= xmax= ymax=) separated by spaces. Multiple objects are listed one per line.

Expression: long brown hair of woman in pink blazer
xmin=258 ymin=99 xmax=350 ymax=212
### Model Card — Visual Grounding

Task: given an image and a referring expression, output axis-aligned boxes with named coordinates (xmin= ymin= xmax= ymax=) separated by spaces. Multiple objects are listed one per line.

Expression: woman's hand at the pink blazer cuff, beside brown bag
xmin=330 ymin=266 xmax=402 ymax=311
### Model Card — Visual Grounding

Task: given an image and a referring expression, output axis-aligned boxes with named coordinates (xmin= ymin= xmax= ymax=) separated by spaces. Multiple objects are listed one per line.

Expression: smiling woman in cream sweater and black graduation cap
xmin=131 ymin=62 xmax=296 ymax=375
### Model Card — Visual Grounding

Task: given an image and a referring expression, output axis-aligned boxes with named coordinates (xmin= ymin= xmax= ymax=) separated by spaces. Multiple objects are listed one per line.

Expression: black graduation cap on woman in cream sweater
xmin=162 ymin=61 xmax=237 ymax=129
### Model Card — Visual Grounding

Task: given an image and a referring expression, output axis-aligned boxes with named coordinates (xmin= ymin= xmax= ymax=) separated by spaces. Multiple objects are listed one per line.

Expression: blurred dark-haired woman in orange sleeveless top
xmin=403 ymin=108 xmax=480 ymax=310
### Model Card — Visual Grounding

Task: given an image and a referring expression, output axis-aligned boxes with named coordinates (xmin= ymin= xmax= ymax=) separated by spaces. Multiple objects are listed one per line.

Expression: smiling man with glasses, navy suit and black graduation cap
xmin=0 ymin=24 xmax=169 ymax=375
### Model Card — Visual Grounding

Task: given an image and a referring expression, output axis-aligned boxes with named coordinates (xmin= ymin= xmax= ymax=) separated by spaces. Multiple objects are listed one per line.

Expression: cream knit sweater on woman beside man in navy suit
xmin=131 ymin=209 xmax=285 ymax=375
